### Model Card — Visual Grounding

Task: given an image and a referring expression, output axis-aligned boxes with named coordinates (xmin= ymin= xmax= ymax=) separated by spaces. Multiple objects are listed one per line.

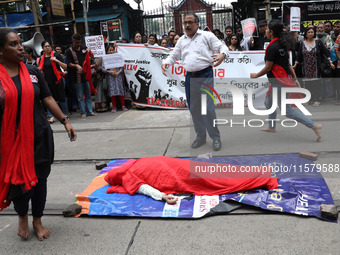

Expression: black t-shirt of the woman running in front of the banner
xmin=265 ymin=41 xmax=289 ymax=78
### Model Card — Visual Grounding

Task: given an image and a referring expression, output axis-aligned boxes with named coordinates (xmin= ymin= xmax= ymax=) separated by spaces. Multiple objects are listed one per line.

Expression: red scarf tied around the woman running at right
xmin=265 ymin=37 xmax=302 ymax=98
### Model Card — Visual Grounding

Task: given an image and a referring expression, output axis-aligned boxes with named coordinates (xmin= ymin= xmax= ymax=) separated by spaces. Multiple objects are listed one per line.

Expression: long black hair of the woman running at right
xmin=268 ymin=20 xmax=295 ymax=51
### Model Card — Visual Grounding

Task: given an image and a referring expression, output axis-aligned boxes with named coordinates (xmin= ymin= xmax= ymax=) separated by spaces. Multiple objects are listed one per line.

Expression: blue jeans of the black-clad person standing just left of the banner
xmin=76 ymin=81 xmax=93 ymax=115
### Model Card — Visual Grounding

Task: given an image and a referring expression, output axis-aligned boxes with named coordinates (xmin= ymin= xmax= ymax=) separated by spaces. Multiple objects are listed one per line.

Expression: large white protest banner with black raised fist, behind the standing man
xmin=117 ymin=44 xmax=269 ymax=109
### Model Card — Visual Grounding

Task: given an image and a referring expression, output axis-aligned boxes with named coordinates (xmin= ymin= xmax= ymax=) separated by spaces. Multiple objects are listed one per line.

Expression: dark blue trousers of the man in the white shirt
xmin=185 ymin=70 xmax=220 ymax=140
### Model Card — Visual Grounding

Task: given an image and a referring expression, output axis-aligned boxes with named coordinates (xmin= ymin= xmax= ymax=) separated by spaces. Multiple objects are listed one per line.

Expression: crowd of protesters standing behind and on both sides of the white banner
xmin=24 ymin=20 xmax=340 ymax=120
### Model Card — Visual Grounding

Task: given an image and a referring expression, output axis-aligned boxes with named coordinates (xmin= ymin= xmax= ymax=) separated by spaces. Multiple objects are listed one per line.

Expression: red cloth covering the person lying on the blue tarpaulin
xmin=105 ymin=156 xmax=278 ymax=195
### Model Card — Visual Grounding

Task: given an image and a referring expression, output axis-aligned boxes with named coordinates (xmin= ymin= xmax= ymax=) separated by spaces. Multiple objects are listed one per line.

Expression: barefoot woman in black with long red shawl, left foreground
xmin=0 ymin=29 xmax=77 ymax=241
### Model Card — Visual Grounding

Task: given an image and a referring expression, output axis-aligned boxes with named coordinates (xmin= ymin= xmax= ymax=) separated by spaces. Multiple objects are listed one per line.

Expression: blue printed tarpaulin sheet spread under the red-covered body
xmin=76 ymin=154 xmax=334 ymax=222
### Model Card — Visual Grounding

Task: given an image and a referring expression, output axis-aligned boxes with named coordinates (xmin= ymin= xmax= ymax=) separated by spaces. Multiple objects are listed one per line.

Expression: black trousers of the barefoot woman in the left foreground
xmin=13 ymin=179 xmax=47 ymax=218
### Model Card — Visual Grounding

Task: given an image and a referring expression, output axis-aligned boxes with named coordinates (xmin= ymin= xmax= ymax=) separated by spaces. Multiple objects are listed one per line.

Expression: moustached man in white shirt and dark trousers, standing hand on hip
xmin=162 ymin=13 xmax=228 ymax=151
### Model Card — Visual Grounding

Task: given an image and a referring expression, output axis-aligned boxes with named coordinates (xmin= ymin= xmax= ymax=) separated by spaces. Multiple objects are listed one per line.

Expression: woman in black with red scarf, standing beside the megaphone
xmin=38 ymin=41 xmax=69 ymax=123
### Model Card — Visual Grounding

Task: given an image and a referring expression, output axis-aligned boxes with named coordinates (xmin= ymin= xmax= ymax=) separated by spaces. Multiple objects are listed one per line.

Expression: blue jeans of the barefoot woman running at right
xmin=264 ymin=83 xmax=314 ymax=128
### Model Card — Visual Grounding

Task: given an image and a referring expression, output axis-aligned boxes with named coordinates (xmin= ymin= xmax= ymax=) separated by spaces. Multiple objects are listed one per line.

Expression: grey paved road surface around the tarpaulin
xmin=0 ymin=102 xmax=340 ymax=254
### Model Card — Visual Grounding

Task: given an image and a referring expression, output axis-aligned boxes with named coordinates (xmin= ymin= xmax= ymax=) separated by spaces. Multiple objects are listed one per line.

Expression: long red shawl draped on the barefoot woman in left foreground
xmin=0 ymin=62 xmax=38 ymax=211
